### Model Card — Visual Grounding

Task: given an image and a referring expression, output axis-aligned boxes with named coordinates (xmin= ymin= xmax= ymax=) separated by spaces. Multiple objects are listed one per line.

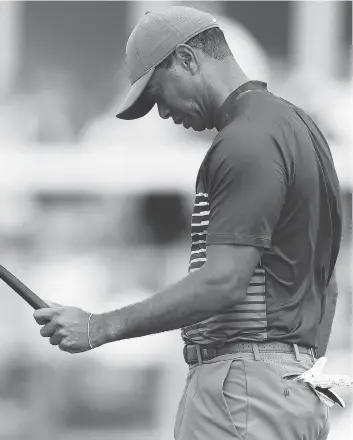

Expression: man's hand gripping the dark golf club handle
xmin=33 ymin=301 xmax=101 ymax=353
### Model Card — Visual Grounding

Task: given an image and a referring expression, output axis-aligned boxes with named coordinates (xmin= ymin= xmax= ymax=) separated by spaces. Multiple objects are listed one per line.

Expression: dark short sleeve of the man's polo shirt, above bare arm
xmin=205 ymin=130 xmax=287 ymax=248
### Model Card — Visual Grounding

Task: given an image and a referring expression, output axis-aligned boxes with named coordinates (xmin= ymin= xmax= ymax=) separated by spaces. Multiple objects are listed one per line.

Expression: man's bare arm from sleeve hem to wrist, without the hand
xmin=92 ymin=245 xmax=261 ymax=346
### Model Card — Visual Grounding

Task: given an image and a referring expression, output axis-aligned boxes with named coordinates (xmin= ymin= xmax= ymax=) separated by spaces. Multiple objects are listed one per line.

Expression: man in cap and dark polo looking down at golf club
xmin=34 ymin=7 xmax=341 ymax=440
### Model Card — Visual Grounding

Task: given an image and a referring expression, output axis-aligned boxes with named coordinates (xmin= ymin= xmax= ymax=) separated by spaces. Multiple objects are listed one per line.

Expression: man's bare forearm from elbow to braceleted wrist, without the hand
xmin=95 ymin=268 xmax=245 ymax=343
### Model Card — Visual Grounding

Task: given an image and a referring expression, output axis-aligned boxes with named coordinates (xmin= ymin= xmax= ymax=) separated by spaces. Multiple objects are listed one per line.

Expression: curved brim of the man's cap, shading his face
xmin=116 ymin=69 xmax=155 ymax=120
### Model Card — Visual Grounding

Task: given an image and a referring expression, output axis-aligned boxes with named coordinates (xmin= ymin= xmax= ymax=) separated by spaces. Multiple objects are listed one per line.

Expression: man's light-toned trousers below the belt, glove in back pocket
xmin=174 ymin=353 xmax=329 ymax=440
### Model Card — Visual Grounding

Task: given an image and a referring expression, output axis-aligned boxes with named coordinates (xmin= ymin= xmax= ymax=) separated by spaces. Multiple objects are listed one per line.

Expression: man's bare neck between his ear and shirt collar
xmin=209 ymin=59 xmax=250 ymax=126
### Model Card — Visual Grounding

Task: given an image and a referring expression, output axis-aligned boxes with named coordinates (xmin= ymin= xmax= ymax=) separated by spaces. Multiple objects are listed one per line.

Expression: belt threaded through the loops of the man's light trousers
xmin=183 ymin=342 xmax=315 ymax=365
